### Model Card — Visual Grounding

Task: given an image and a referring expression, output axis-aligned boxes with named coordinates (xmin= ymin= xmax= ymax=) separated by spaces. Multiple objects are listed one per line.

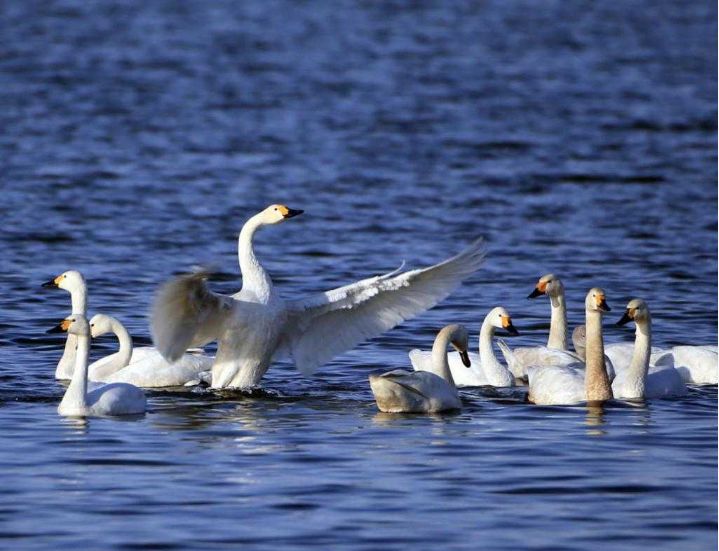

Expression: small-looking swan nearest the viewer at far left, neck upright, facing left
xmin=48 ymin=314 xmax=147 ymax=417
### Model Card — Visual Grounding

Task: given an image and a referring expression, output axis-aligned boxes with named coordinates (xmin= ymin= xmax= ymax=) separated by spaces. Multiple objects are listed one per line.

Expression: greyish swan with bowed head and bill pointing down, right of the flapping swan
xmin=369 ymin=325 xmax=471 ymax=413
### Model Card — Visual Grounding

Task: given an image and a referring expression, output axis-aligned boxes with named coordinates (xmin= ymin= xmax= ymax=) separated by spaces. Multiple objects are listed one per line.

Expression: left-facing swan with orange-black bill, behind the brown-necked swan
xmin=500 ymin=274 xmax=579 ymax=379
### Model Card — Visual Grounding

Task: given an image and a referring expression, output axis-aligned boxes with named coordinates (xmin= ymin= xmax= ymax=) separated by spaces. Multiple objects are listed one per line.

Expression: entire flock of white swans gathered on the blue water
xmin=43 ymin=204 xmax=717 ymax=416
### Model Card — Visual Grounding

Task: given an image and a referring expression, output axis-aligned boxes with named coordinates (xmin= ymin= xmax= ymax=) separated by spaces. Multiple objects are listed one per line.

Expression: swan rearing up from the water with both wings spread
xmin=151 ymin=205 xmax=484 ymax=388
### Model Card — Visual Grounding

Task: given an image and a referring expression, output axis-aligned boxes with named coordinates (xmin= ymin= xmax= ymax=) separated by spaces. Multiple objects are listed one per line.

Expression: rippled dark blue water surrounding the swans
xmin=0 ymin=2 xmax=717 ymax=550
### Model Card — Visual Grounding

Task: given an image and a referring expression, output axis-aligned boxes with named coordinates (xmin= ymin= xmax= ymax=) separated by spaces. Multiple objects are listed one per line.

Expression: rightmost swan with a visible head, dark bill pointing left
xmin=612 ymin=298 xmax=687 ymax=400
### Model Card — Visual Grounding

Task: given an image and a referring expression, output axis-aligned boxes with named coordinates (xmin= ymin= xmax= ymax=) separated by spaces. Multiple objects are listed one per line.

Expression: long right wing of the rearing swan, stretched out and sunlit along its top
xmin=283 ymin=239 xmax=485 ymax=375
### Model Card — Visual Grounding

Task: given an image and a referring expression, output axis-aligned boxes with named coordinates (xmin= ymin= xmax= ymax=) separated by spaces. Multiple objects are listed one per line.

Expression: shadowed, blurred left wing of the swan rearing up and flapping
xmin=150 ymin=271 xmax=234 ymax=362
